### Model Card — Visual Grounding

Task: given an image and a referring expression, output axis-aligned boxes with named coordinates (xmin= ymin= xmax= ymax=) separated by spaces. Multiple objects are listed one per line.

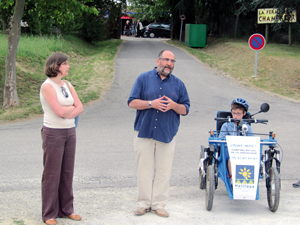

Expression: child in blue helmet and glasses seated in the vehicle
xmin=219 ymin=98 xmax=253 ymax=178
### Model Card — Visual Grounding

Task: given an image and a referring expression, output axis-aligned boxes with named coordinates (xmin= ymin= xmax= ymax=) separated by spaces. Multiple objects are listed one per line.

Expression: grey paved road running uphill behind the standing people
xmin=0 ymin=37 xmax=300 ymax=225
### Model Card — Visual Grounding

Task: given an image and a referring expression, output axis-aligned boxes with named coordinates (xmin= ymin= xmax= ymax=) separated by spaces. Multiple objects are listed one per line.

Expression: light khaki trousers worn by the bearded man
xmin=134 ymin=131 xmax=175 ymax=210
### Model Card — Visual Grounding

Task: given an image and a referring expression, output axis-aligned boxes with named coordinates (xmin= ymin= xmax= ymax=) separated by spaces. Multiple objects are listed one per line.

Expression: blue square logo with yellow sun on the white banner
xmin=235 ymin=165 xmax=254 ymax=184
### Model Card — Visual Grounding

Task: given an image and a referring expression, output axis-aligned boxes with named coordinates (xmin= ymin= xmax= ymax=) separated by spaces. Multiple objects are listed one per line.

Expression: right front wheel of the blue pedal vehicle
xmin=267 ymin=167 xmax=280 ymax=212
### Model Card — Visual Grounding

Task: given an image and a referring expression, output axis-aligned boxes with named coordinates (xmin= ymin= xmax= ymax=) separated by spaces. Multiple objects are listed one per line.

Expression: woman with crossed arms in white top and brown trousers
xmin=40 ymin=53 xmax=83 ymax=224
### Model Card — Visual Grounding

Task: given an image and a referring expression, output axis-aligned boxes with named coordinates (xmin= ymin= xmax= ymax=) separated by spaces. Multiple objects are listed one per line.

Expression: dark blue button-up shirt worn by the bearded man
xmin=127 ymin=67 xmax=190 ymax=143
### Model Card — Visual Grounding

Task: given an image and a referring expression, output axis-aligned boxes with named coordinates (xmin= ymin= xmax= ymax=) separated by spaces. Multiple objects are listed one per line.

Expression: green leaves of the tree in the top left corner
xmin=0 ymin=0 xmax=99 ymax=35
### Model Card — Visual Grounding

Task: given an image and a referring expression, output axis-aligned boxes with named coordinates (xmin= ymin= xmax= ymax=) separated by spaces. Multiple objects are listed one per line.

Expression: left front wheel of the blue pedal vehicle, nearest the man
xmin=205 ymin=165 xmax=215 ymax=211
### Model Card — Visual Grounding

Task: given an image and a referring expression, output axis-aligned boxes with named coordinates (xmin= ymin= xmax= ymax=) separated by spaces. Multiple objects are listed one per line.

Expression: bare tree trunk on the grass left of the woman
xmin=2 ymin=0 xmax=25 ymax=110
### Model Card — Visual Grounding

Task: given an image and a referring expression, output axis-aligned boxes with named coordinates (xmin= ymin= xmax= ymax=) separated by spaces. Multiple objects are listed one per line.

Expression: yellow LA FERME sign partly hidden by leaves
xmin=257 ymin=8 xmax=297 ymax=24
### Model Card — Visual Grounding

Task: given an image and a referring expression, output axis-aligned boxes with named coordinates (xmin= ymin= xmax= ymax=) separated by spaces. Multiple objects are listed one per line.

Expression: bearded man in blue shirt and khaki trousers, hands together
xmin=128 ymin=50 xmax=190 ymax=217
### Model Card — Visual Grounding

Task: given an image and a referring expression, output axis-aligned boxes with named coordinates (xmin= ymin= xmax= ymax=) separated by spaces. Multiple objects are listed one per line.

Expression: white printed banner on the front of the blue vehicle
xmin=226 ymin=136 xmax=260 ymax=200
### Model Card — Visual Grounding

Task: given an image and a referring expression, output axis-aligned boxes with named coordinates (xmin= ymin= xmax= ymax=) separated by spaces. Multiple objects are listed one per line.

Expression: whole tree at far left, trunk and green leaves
xmin=0 ymin=0 xmax=98 ymax=110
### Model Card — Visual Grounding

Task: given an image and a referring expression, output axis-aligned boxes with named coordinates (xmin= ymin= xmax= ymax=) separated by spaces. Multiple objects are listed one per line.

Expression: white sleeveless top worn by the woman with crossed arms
xmin=40 ymin=78 xmax=75 ymax=129
